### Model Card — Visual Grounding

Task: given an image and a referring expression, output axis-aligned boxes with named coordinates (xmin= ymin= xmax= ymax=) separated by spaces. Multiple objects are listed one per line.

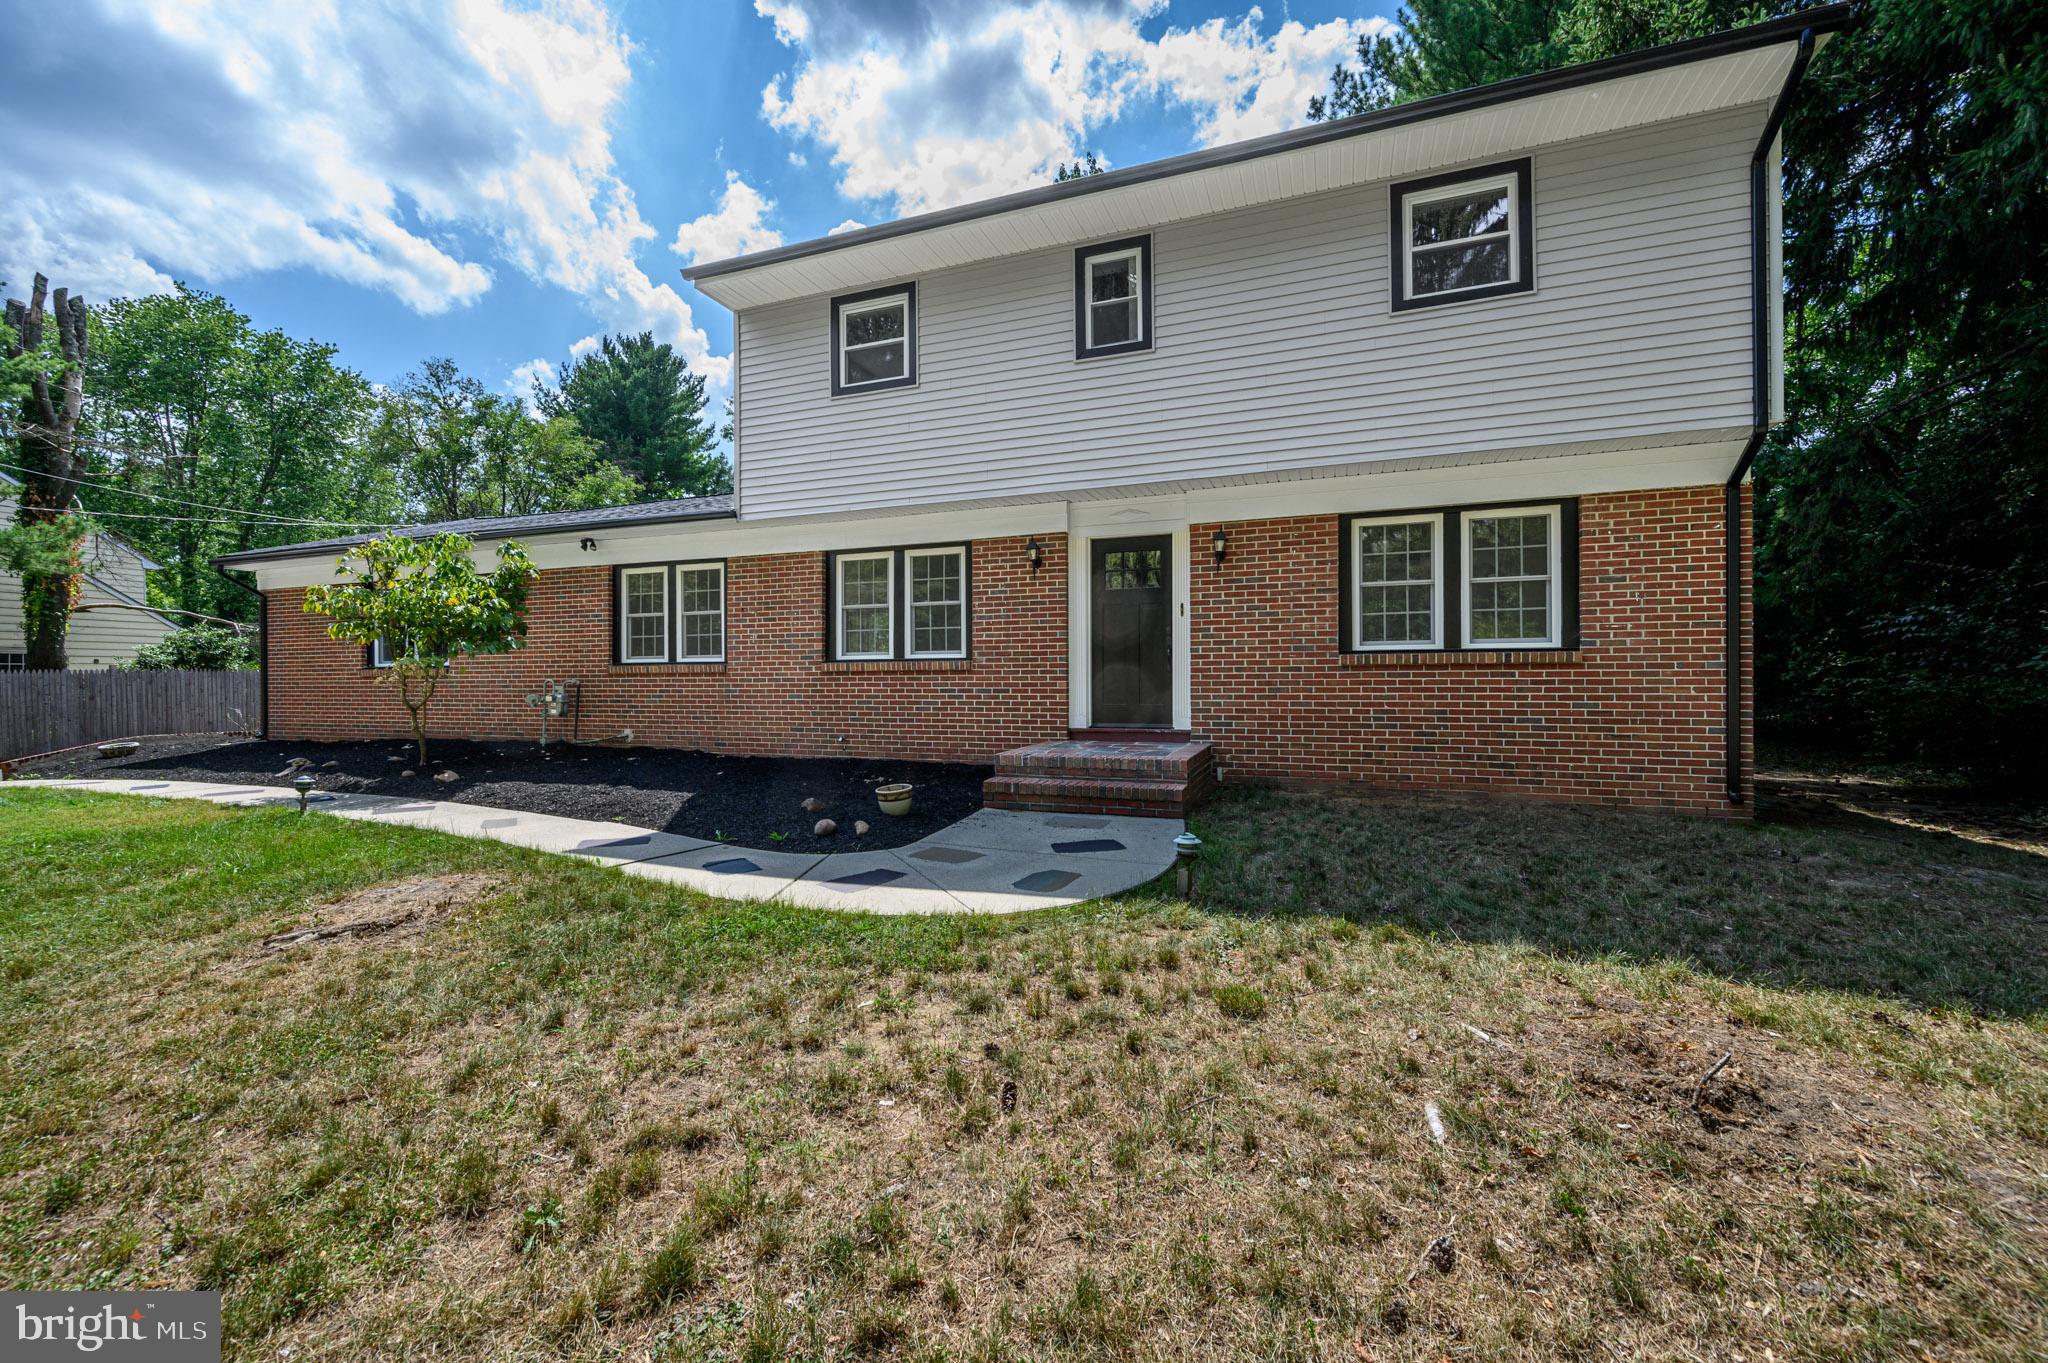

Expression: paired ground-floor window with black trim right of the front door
xmin=1341 ymin=501 xmax=1579 ymax=653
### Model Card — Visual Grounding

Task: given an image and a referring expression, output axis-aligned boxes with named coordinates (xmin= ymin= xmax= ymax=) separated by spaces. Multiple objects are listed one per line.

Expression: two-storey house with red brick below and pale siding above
xmin=223 ymin=6 xmax=1847 ymax=812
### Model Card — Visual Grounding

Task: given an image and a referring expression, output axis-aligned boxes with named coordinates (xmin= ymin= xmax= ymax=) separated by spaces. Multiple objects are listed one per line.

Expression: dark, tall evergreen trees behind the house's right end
xmin=1311 ymin=0 xmax=2048 ymax=774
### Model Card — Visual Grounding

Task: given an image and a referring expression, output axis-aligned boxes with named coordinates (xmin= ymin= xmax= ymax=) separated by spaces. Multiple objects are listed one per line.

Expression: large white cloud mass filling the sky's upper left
xmin=0 ymin=0 xmax=729 ymax=381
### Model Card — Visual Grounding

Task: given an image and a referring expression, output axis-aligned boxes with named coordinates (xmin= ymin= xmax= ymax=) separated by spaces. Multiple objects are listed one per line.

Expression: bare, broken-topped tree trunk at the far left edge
xmin=6 ymin=274 xmax=86 ymax=671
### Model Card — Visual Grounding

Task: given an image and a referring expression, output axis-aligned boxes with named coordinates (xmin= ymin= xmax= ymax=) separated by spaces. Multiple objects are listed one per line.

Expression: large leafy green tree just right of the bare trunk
xmin=80 ymin=284 xmax=399 ymax=618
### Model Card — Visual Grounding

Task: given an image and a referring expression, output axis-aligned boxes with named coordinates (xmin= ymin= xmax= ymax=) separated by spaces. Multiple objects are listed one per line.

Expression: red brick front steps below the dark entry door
xmin=981 ymin=739 xmax=1217 ymax=819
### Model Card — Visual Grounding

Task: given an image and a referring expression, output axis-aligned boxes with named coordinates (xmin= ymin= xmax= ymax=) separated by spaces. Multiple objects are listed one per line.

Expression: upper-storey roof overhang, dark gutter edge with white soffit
xmin=684 ymin=4 xmax=1851 ymax=311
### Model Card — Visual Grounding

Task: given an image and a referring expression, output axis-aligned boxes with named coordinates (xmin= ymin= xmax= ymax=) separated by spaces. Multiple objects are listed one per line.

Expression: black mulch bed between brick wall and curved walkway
xmin=16 ymin=739 xmax=989 ymax=851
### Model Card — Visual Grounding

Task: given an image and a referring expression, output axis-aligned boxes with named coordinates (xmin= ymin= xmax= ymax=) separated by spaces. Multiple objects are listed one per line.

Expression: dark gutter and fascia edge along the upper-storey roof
xmin=682 ymin=0 xmax=1853 ymax=284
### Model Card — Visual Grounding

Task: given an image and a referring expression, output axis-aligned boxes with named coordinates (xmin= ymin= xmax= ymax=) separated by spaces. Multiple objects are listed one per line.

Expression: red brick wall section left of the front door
xmin=270 ymin=534 xmax=1067 ymax=761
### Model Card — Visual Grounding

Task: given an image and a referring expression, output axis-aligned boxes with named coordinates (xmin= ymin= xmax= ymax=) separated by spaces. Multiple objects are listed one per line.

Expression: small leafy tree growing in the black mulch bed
xmin=305 ymin=534 xmax=541 ymax=767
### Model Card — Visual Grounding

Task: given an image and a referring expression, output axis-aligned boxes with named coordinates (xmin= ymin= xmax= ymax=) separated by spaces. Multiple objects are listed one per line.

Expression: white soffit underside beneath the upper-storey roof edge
xmin=696 ymin=39 xmax=1796 ymax=311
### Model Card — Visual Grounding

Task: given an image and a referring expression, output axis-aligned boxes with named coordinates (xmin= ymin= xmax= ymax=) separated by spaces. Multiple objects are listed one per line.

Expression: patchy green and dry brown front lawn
xmin=0 ymin=790 xmax=2048 ymax=1363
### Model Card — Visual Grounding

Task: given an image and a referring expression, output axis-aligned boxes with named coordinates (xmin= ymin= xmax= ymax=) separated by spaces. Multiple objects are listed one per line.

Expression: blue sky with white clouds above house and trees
xmin=0 ymin=0 xmax=1386 ymax=397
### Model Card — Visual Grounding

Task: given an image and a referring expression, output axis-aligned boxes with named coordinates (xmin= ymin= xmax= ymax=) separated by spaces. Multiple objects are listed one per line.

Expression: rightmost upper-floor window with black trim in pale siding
xmin=1389 ymin=158 xmax=1536 ymax=311
